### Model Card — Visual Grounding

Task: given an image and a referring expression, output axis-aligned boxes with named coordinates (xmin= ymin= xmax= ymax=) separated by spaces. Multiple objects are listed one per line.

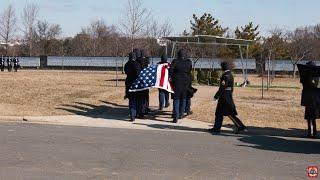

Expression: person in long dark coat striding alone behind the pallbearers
xmin=210 ymin=62 xmax=246 ymax=133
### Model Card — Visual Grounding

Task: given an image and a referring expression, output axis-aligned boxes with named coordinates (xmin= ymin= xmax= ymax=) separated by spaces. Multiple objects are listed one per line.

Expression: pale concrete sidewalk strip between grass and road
xmin=0 ymin=115 xmax=232 ymax=133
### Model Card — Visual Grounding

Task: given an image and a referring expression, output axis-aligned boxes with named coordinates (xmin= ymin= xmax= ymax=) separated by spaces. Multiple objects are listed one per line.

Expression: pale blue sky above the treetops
xmin=0 ymin=0 xmax=320 ymax=36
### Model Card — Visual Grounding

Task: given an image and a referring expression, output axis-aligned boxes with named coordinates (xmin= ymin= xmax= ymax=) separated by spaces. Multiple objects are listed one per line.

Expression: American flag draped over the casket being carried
xmin=129 ymin=63 xmax=174 ymax=93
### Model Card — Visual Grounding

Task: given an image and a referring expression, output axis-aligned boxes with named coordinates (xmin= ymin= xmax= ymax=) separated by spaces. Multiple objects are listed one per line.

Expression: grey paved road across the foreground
xmin=0 ymin=123 xmax=320 ymax=180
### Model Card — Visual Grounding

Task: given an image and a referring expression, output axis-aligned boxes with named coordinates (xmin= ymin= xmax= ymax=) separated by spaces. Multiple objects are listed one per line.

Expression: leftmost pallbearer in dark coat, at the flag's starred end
xmin=124 ymin=52 xmax=141 ymax=121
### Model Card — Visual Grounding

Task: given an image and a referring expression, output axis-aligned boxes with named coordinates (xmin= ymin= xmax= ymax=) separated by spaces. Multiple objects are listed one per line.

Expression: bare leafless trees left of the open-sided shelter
xmin=0 ymin=0 xmax=172 ymax=56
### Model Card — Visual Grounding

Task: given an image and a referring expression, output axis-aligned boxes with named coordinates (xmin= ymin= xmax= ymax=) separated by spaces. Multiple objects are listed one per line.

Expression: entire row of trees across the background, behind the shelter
xmin=0 ymin=0 xmax=320 ymax=74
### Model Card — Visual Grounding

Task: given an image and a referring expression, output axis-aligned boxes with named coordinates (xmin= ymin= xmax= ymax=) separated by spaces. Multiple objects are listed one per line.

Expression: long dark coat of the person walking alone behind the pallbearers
xmin=214 ymin=70 xmax=238 ymax=116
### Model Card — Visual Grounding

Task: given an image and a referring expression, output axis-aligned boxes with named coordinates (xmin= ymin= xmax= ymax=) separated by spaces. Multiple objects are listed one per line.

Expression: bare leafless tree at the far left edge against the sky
xmin=0 ymin=5 xmax=17 ymax=55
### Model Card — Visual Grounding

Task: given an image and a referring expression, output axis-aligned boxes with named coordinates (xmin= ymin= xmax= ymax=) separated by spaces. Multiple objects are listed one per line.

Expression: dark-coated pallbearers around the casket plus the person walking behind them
xmin=125 ymin=49 xmax=247 ymax=133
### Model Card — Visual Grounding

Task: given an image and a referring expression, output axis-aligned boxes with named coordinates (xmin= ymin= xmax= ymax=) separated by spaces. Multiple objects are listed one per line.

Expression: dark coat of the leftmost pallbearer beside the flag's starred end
xmin=124 ymin=61 xmax=141 ymax=99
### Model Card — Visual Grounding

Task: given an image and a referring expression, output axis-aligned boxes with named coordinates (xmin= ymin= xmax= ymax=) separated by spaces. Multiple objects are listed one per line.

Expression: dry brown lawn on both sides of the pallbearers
xmin=0 ymin=70 xmax=316 ymax=129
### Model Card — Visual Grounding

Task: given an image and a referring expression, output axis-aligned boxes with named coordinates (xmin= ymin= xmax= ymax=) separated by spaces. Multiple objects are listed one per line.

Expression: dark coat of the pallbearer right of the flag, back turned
xmin=170 ymin=58 xmax=192 ymax=99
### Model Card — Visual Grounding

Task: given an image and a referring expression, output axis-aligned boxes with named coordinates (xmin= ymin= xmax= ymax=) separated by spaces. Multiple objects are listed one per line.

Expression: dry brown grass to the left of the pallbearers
xmin=0 ymin=70 xmax=124 ymax=116
